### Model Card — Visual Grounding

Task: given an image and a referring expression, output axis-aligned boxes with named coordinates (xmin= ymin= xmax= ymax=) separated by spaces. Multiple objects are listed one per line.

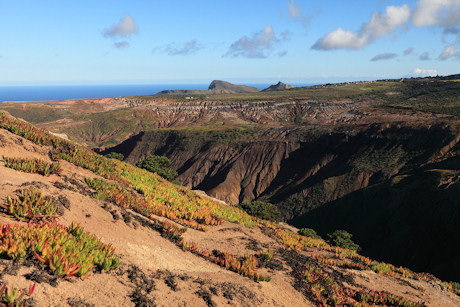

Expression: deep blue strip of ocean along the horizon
xmin=0 ymin=84 xmax=300 ymax=103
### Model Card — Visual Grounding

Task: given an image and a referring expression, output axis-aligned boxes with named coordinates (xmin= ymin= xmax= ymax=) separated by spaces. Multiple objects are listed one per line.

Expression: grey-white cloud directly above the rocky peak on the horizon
xmin=223 ymin=26 xmax=279 ymax=58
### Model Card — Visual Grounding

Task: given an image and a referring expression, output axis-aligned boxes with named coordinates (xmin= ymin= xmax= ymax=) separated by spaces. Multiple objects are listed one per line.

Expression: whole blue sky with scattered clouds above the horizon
xmin=0 ymin=0 xmax=460 ymax=85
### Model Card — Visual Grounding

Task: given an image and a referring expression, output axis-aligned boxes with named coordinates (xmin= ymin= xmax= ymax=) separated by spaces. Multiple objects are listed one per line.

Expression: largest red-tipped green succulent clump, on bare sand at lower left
xmin=0 ymin=223 xmax=120 ymax=277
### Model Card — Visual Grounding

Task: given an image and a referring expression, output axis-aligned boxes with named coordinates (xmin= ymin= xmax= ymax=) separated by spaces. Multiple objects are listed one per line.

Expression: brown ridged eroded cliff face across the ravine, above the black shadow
xmin=107 ymin=125 xmax=458 ymax=220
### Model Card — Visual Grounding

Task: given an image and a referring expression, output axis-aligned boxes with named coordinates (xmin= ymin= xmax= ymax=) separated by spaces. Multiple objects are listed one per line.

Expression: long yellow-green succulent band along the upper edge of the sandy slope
xmin=0 ymin=112 xmax=255 ymax=231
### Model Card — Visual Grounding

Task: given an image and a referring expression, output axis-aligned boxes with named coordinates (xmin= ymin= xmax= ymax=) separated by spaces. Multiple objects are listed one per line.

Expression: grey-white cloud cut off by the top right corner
xmin=412 ymin=0 xmax=460 ymax=27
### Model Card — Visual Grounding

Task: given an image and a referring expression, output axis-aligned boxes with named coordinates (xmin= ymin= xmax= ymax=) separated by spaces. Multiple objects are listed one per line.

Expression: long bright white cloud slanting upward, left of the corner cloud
xmin=312 ymin=4 xmax=410 ymax=50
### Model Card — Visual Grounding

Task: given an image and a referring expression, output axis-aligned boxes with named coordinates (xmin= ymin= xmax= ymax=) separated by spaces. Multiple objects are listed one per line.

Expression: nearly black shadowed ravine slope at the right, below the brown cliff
xmin=292 ymin=156 xmax=460 ymax=280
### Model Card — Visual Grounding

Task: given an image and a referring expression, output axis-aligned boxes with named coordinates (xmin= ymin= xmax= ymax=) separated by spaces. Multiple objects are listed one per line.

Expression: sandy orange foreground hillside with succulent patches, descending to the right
xmin=0 ymin=113 xmax=460 ymax=306
